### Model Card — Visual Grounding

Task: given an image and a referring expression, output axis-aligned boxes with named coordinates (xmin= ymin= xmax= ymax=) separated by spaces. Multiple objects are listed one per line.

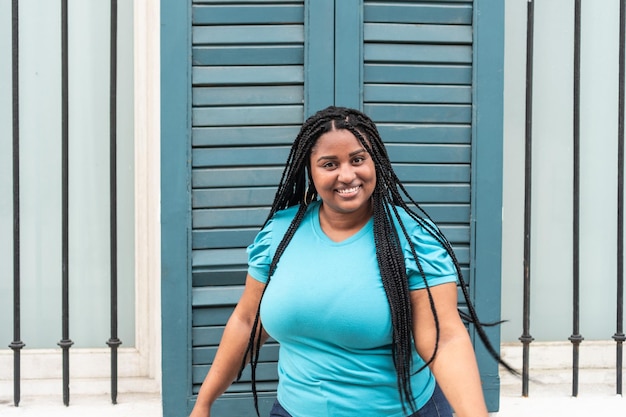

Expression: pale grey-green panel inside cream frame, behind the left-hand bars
xmin=0 ymin=0 xmax=135 ymax=348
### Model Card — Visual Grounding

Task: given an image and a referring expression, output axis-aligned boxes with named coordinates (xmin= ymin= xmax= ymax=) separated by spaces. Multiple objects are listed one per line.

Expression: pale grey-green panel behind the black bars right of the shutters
xmin=502 ymin=0 xmax=619 ymax=342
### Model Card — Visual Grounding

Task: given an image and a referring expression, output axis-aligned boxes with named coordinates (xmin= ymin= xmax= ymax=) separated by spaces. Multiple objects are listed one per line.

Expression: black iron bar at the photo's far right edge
xmin=613 ymin=0 xmax=626 ymax=395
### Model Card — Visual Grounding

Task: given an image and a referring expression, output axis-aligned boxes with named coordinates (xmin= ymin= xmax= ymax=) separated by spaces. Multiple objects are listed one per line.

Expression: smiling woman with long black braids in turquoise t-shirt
xmin=191 ymin=107 xmax=488 ymax=417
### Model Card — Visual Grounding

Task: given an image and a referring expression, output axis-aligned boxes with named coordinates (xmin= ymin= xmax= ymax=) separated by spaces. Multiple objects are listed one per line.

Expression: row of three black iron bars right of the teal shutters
xmin=519 ymin=0 xmax=626 ymax=396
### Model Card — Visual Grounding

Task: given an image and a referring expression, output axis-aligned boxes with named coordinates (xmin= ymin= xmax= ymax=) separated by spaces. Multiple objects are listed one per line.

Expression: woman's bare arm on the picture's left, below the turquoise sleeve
xmin=190 ymin=275 xmax=268 ymax=417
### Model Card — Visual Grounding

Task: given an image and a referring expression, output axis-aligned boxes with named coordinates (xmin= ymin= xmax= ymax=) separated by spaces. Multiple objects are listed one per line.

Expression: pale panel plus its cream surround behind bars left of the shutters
xmin=0 ymin=0 xmax=161 ymax=395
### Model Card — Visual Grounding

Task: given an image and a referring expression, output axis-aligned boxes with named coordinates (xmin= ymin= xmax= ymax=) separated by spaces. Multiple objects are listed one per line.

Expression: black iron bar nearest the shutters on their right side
xmin=519 ymin=0 xmax=534 ymax=397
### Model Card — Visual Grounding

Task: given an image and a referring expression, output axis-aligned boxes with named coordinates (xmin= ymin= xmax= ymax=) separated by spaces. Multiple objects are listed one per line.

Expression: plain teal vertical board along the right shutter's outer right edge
xmin=470 ymin=0 xmax=504 ymax=412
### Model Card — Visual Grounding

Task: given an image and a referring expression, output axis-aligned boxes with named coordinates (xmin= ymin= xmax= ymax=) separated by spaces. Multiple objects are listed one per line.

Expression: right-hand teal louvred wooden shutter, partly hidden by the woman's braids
xmin=335 ymin=0 xmax=503 ymax=411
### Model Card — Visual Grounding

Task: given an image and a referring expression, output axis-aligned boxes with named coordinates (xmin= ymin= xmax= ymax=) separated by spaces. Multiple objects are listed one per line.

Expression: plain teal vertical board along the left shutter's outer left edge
xmin=161 ymin=0 xmax=192 ymax=417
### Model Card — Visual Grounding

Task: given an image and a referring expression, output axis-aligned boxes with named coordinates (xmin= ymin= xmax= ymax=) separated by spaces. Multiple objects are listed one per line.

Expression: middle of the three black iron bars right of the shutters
xmin=569 ymin=0 xmax=583 ymax=397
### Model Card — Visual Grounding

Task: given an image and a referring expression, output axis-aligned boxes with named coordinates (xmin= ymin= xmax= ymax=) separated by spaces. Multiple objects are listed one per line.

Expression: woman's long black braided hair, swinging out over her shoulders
xmin=239 ymin=106 xmax=516 ymax=415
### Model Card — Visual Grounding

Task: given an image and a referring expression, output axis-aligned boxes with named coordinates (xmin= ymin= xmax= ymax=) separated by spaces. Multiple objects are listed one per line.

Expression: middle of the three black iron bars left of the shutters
xmin=58 ymin=0 xmax=74 ymax=406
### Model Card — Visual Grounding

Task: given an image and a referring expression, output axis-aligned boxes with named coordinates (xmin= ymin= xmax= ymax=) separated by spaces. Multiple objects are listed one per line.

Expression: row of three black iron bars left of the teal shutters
xmin=9 ymin=0 xmax=122 ymax=406
